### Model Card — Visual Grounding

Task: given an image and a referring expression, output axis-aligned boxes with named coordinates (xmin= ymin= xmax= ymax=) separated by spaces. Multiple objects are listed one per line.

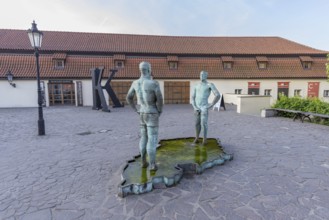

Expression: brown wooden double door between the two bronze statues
xmin=164 ymin=81 xmax=190 ymax=104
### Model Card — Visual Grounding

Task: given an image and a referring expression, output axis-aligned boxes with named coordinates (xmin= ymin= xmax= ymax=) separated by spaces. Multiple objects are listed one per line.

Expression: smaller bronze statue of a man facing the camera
xmin=192 ymin=71 xmax=220 ymax=145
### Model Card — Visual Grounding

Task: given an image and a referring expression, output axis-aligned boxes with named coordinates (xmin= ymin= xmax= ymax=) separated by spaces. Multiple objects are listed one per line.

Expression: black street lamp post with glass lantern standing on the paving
xmin=27 ymin=21 xmax=45 ymax=135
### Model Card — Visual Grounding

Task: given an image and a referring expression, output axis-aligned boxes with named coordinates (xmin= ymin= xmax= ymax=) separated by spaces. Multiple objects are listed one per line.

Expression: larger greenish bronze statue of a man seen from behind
xmin=126 ymin=62 xmax=163 ymax=170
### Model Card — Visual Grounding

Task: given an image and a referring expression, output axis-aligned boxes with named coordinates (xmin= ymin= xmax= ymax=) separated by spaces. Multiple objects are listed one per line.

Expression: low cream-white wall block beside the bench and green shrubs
xmin=237 ymin=95 xmax=271 ymax=116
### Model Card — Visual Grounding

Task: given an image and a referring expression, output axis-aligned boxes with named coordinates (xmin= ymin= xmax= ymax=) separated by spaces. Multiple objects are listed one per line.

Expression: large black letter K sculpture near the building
xmin=90 ymin=67 xmax=124 ymax=112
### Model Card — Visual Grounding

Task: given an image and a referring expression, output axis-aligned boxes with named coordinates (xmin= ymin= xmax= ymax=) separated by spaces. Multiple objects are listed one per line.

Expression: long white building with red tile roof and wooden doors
xmin=0 ymin=29 xmax=329 ymax=108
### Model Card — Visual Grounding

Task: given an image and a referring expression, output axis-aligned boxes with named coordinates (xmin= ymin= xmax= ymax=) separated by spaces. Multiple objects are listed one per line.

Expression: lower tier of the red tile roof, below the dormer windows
xmin=0 ymin=54 xmax=327 ymax=79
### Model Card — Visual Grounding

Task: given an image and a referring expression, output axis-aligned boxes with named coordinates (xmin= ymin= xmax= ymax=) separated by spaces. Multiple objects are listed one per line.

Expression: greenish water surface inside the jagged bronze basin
xmin=123 ymin=138 xmax=223 ymax=185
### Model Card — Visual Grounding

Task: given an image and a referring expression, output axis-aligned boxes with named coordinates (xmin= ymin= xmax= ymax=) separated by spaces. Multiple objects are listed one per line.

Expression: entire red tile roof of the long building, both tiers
xmin=0 ymin=29 xmax=328 ymax=79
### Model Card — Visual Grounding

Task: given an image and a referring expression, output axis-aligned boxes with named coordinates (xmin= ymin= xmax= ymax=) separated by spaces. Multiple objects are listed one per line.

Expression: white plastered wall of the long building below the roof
xmin=0 ymin=79 xmax=329 ymax=108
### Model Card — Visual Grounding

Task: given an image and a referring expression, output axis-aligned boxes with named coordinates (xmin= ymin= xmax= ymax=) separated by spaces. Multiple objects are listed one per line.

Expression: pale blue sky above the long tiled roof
xmin=0 ymin=0 xmax=329 ymax=51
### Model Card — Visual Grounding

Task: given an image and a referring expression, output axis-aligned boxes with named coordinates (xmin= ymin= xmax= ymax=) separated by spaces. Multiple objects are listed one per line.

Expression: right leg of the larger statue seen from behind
xmin=146 ymin=127 xmax=159 ymax=170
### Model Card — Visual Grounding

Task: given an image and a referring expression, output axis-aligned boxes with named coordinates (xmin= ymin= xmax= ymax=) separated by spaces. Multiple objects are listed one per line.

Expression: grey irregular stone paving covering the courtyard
xmin=0 ymin=105 xmax=329 ymax=220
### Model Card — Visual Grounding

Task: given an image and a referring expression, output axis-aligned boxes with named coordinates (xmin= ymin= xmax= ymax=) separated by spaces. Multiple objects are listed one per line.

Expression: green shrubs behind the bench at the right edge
xmin=272 ymin=96 xmax=329 ymax=125
